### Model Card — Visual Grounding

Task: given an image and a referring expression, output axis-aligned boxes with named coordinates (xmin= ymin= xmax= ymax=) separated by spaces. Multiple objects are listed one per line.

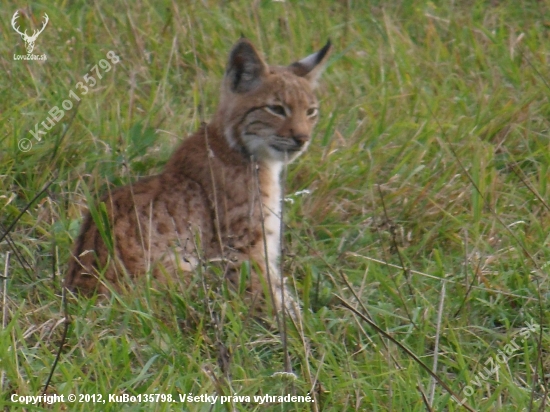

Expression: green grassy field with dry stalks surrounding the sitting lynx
xmin=0 ymin=0 xmax=550 ymax=411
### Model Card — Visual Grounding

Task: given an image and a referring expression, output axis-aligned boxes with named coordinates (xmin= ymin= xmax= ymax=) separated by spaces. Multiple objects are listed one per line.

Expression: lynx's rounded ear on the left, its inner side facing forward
xmin=225 ymin=38 xmax=267 ymax=93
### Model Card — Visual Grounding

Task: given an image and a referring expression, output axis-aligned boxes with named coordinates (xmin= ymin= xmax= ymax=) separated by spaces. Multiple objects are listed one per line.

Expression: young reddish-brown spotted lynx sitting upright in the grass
xmin=65 ymin=39 xmax=331 ymax=313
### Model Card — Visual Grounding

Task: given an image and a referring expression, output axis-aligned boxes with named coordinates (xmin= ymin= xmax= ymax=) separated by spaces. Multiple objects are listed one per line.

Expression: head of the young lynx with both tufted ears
xmin=217 ymin=39 xmax=331 ymax=162
